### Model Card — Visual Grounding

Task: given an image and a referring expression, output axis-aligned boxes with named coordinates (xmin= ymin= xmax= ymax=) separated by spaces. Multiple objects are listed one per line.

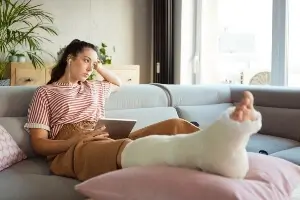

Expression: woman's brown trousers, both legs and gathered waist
xmin=48 ymin=119 xmax=199 ymax=181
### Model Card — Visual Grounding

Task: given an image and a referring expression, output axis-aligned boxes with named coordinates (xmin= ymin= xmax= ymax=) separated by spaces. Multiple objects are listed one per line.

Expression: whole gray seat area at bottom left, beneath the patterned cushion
xmin=0 ymin=157 xmax=84 ymax=200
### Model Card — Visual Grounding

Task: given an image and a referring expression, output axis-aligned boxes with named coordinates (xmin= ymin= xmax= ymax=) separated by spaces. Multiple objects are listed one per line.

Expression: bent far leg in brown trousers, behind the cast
xmin=129 ymin=118 xmax=200 ymax=140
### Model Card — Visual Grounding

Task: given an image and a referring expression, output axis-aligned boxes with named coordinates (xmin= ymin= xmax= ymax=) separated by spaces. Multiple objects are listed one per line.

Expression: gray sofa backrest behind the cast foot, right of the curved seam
xmin=160 ymin=84 xmax=300 ymax=141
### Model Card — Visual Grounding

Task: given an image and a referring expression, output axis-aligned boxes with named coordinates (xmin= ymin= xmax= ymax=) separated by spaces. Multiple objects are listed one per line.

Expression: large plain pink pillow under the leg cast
xmin=75 ymin=153 xmax=300 ymax=200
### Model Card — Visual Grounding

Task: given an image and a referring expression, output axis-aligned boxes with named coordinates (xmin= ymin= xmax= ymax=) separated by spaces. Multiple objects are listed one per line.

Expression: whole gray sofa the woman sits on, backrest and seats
xmin=0 ymin=84 xmax=300 ymax=200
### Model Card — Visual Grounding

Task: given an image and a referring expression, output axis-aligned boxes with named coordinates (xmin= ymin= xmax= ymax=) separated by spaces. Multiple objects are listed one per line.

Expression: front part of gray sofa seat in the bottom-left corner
xmin=0 ymin=172 xmax=85 ymax=200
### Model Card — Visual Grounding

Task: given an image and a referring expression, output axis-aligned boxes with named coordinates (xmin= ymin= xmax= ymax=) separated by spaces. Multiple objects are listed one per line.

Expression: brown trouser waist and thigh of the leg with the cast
xmin=48 ymin=122 xmax=131 ymax=181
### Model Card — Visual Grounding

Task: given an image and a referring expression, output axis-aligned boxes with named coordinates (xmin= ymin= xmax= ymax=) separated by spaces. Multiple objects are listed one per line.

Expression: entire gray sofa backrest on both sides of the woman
xmin=0 ymin=84 xmax=300 ymax=156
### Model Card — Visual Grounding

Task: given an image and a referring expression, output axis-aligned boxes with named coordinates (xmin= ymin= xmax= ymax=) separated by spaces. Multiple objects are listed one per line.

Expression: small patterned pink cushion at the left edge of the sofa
xmin=0 ymin=125 xmax=27 ymax=171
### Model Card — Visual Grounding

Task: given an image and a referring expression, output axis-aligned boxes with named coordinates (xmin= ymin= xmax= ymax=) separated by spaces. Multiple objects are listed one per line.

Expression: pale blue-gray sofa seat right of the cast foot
xmin=247 ymin=133 xmax=300 ymax=154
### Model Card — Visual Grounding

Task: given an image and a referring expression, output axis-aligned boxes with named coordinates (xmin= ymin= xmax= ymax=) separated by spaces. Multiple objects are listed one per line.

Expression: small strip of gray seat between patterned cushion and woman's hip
xmin=0 ymin=157 xmax=50 ymax=175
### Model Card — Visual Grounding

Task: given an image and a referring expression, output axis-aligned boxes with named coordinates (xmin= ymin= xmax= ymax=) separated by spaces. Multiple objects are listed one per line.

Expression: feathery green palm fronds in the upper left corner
xmin=0 ymin=0 xmax=57 ymax=68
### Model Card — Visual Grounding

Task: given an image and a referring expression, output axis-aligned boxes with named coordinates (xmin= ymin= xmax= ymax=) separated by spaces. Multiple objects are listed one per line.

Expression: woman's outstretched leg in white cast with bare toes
xmin=121 ymin=92 xmax=261 ymax=178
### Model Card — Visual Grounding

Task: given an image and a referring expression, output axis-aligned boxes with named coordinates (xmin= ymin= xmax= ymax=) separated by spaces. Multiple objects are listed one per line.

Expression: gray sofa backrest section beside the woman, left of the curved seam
xmin=106 ymin=84 xmax=178 ymax=131
